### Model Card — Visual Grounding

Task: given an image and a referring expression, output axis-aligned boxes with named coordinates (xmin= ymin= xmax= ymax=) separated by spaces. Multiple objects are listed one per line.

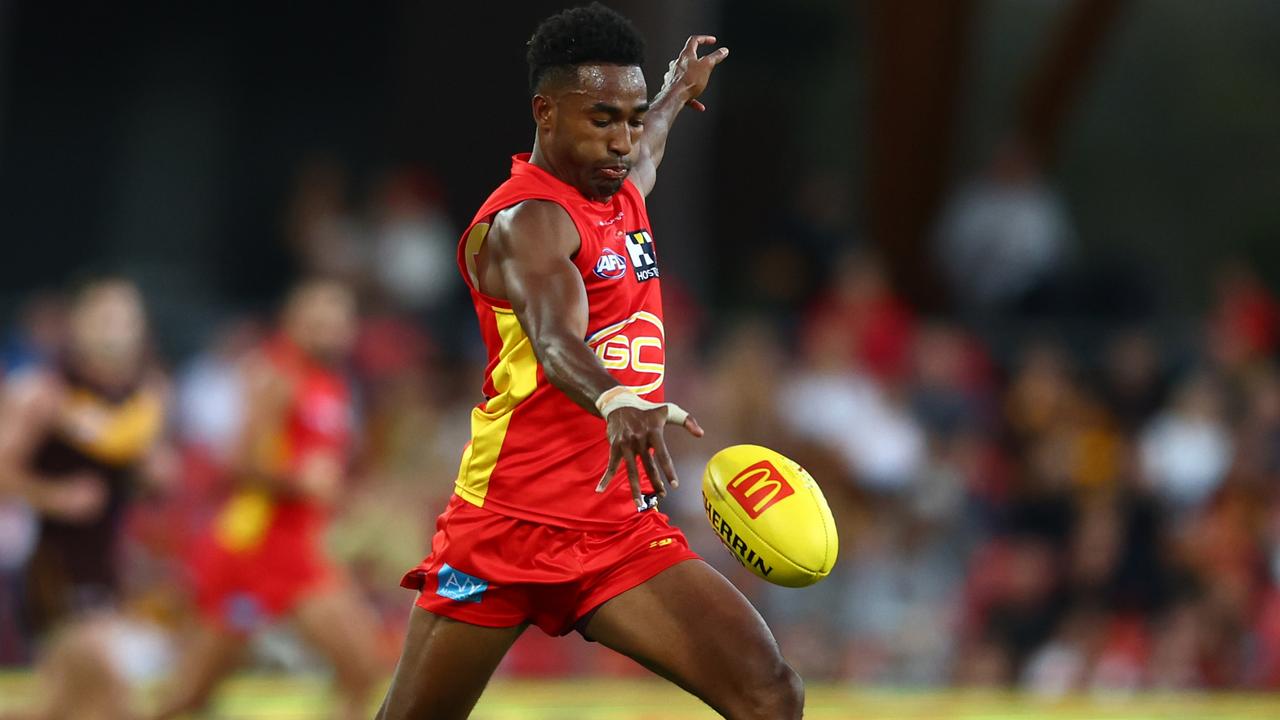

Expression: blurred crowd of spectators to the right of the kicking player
xmin=711 ymin=255 xmax=1280 ymax=694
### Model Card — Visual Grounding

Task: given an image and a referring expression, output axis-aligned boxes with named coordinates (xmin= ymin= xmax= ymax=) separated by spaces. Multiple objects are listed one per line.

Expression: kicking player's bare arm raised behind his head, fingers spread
xmin=631 ymin=35 xmax=728 ymax=195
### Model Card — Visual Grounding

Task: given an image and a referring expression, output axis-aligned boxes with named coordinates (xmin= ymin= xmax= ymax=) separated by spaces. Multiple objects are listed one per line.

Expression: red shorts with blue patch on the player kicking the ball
xmin=401 ymin=496 xmax=698 ymax=635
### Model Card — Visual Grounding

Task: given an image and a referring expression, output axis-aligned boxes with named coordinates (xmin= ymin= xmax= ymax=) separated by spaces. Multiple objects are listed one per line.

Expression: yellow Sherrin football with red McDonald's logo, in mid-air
xmin=703 ymin=445 xmax=840 ymax=588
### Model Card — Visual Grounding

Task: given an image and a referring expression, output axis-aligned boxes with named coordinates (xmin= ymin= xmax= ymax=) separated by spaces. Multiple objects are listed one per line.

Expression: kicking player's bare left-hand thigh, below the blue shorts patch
xmin=378 ymin=605 xmax=525 ymax=720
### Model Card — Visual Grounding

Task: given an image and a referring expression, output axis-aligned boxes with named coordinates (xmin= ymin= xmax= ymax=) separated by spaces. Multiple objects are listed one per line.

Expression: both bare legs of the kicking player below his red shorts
xmin=378 ymin=560 xmax=804 ymax=720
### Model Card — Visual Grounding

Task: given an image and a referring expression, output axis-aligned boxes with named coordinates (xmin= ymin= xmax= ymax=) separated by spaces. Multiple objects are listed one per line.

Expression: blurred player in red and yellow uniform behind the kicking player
xmin=156 ymin=281 xmax=378 ymax=719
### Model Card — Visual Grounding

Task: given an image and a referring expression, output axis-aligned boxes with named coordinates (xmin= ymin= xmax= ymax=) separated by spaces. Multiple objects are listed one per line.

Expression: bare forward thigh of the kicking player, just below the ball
xmin=586 ymin=560 xmax=804 ymax=720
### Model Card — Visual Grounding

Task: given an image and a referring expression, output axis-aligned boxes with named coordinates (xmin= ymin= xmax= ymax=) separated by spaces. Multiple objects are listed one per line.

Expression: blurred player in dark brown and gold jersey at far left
xmin=0 ymin=278 xmax=166 ymax=720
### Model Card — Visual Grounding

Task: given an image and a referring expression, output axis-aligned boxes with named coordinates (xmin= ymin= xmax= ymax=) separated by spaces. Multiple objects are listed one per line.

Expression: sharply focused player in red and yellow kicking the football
xmin=379 ymin=4 xmax=804 ymax=720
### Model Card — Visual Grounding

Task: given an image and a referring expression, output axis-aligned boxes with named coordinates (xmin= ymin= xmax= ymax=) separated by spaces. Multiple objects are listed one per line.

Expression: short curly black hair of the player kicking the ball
xmin=527 ymin=3 xmax=644 ymax=92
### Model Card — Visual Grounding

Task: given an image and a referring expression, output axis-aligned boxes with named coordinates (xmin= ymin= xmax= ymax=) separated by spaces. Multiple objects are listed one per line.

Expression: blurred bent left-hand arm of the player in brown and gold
xmin=0 ymin=373 xmax=106 ymax=521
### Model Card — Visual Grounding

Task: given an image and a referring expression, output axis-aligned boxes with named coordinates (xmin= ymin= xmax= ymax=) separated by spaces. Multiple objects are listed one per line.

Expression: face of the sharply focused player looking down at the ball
xmin=543 ymin=65 xmax=649 ymax=199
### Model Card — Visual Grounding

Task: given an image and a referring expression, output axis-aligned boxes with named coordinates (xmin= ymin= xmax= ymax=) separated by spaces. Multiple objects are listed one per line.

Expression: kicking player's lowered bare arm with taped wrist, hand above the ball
xmin=477 ymin=201 xmax=703 ymax=507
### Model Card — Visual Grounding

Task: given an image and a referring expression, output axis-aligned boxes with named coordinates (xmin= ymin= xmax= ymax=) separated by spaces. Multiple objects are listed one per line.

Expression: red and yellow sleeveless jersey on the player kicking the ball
xmin=454 ymin=154 xmax=666 ymax=529
